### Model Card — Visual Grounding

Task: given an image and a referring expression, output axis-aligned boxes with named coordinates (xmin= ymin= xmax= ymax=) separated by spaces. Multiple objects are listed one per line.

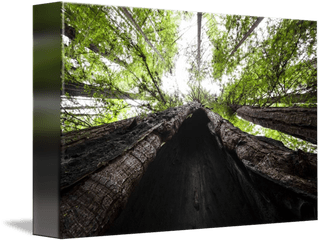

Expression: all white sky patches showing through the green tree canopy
xmin=62 ymin=9 xmax=316 ymax=120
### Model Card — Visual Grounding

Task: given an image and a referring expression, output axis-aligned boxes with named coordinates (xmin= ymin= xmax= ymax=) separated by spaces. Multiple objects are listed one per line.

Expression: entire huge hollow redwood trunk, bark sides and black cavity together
xmin=60 ymin=106 xmax=318 ymax=238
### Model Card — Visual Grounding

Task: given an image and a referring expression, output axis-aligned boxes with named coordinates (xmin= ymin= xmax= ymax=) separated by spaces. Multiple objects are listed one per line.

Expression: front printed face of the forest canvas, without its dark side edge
xmin=59 ymin=2 xmax=318 ymax=238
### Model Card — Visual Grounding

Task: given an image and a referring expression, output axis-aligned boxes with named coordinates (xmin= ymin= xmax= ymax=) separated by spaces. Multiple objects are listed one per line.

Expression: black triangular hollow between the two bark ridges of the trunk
xmin=104 ymin=109 xmax=317 ymax=236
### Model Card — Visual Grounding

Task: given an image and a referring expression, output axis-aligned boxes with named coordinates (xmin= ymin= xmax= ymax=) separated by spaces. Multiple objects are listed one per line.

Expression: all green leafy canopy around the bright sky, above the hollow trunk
xmin=61 ymin=2 xmax=318 ymax=151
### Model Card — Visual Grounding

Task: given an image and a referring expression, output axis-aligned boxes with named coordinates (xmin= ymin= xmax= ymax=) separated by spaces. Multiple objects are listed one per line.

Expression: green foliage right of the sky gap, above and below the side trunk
xmin=204 ymin=15 xmax=318 ymax=152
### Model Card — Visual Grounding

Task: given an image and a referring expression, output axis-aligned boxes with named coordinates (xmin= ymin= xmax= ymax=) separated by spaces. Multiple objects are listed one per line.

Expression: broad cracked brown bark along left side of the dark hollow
xmin=60 ymin=103 xmax=200 ymax=238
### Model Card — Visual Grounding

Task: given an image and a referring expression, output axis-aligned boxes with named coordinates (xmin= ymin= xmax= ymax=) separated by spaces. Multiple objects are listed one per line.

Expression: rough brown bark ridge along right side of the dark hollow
xmin=205 ymin=109 xmax=318 ymax=198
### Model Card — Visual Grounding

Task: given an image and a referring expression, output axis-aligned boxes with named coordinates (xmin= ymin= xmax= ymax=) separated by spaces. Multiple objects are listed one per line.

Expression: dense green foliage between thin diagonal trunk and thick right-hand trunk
xmin=221 ymin=19 xmax=318 ymax=107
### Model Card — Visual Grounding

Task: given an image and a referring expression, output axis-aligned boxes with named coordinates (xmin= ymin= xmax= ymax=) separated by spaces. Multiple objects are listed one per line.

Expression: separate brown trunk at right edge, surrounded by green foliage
xmin=236 ymin=106 xmax=318 ymax=144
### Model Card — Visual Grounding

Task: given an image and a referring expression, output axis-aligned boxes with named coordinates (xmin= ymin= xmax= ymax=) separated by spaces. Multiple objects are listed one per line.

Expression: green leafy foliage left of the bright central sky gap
xmin=61 ymin=3 xmax=181 ymax=131
